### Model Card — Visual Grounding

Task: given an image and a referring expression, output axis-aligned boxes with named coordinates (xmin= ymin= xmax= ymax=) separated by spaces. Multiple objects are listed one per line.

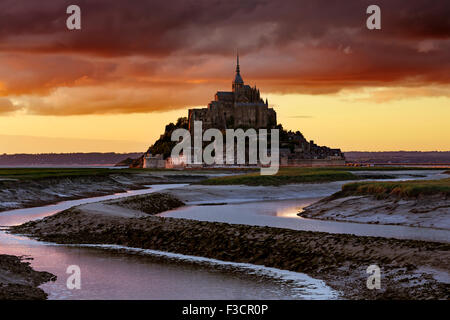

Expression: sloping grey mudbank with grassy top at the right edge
xmin=299 ymin=178 xmax=450 ymax=230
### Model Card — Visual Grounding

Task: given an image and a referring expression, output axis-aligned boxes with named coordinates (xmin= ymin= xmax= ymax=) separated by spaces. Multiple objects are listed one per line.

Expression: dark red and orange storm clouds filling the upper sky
xmin=0 ymin=0 xmax=450 ymax=112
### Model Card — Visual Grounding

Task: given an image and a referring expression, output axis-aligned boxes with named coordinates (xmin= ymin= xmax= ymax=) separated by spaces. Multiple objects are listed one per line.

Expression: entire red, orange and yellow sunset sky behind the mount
xmin=0 ymin=0 xmax=450 ymax=153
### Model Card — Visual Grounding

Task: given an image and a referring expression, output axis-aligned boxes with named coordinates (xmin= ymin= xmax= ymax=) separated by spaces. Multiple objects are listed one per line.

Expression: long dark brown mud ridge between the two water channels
xmin=11 ymin=205 xmax=450 ymax=299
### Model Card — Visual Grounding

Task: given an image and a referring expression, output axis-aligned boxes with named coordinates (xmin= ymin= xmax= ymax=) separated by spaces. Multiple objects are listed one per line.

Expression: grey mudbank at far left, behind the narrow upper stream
xmin=0 ymin=169 xmax=207 ymax=212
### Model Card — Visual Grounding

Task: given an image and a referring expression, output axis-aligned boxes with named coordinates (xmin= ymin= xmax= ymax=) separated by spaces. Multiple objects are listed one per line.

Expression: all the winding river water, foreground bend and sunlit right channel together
xmin=0 ymin=172 xmax=450 ymax=299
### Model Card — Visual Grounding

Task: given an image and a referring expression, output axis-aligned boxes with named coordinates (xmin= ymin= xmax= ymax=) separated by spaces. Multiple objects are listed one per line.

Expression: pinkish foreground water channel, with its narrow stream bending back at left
xmin=0 ymin=185 xmax=336 ymax=299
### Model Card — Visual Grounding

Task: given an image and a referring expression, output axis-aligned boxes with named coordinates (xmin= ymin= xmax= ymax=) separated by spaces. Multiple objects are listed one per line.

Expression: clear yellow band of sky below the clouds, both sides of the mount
xmin=0 ymin=89 xmax=450 ymax=153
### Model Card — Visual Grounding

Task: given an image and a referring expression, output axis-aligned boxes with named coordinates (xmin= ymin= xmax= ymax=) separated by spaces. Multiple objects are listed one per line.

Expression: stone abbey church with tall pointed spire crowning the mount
xmin=188 ymin=55 xmax=277 ymax=132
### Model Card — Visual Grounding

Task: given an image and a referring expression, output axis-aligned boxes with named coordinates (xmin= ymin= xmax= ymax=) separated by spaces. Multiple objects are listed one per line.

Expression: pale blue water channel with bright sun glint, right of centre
xmin=159 ymin=198 xmax=450 ymax=242
